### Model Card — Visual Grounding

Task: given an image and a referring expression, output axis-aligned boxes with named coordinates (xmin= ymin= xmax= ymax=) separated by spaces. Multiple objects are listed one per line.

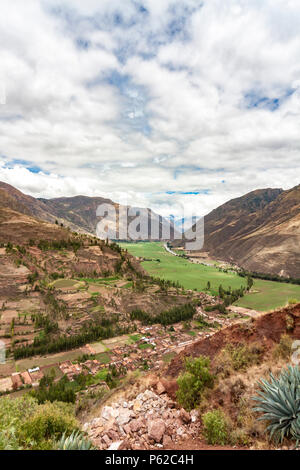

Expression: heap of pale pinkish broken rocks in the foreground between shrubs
xmin=83 ymin=389 xmax=200 ymax=450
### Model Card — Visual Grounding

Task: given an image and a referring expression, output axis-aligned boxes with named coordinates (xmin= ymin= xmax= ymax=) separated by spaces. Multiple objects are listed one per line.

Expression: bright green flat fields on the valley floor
xmin=120 ymin=242 xmax=300 ymax=311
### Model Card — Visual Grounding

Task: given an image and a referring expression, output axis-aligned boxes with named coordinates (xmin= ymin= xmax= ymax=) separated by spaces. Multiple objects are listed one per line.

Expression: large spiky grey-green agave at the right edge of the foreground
xmin=253 ymin=366 xmax=300 ymax=446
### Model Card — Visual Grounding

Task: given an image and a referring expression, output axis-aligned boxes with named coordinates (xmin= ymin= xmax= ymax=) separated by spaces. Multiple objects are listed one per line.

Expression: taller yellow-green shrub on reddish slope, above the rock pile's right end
xmin=176 ymin=356 xmax=214 ymax=411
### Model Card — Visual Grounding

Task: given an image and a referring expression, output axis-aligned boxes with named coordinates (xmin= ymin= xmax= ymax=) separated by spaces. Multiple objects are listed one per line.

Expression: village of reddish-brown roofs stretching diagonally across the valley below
xmin=0 ymin=307 xmax=245 ymax=394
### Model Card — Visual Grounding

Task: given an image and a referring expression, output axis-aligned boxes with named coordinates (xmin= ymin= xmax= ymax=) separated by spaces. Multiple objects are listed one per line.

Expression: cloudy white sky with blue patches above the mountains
xmin=0 ymin=0 xmax=300 ymax=217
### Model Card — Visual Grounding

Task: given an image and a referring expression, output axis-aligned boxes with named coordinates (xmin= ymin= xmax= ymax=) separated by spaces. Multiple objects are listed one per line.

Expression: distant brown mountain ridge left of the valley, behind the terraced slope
xmin=0 ymin=182 xmax=181 ymax=240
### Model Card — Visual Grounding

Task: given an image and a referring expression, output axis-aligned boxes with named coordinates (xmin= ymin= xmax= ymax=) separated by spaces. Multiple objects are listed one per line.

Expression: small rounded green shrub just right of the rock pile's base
xmin=202 ymin=410 xmax=229 ymax=445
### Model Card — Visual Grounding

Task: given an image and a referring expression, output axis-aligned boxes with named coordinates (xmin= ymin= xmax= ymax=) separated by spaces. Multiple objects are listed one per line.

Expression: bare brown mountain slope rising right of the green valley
xmin=186 ymin=185 xmax=300 ymax=277
